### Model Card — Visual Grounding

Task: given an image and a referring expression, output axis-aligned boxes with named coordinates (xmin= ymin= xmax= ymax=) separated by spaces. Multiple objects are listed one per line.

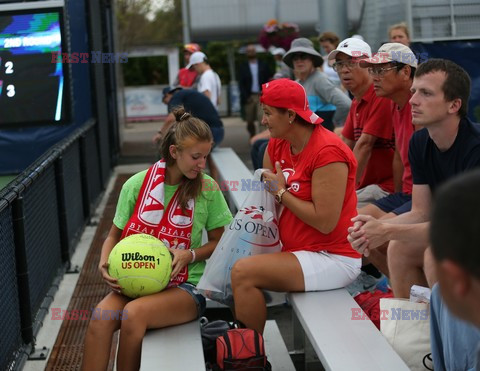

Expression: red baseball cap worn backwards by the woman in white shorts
xmin=260 ymin=79 xmax=323 ymax=124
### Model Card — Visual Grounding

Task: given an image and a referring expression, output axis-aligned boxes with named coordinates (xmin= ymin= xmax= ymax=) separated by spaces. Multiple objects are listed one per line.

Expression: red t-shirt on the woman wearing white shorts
xmin=267 ymin=125 xmax=360 ymax=258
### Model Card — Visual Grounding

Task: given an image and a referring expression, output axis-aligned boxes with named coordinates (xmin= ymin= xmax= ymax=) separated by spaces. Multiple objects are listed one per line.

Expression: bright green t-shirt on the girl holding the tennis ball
xmin=113 ymin=170 xmax=232 ymax=285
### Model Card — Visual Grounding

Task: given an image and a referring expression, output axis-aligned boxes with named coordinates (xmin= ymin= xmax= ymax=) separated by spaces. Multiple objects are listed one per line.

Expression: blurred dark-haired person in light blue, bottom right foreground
xmin=430 ymin=170 xmax=480 ymax=371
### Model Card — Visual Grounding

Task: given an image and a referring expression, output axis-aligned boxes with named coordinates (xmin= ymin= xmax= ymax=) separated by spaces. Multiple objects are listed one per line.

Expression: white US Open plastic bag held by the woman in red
xmin=197 ymin=169 xmax=282 ymax=306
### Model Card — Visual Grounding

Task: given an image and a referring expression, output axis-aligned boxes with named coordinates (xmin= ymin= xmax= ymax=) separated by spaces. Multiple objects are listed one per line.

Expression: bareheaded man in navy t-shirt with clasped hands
xmin=349 ymin=59 xmax=480 ymax=298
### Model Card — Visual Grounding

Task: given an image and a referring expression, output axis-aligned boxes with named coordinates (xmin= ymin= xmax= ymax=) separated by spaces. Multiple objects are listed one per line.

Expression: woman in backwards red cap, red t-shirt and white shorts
xmin=232 ymin=79 xmax=361 ymax=333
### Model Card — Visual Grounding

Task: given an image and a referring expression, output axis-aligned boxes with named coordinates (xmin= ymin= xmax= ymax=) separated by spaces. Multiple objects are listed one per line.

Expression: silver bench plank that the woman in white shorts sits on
xmin=288 ymin=289 xmax=408 ymax=371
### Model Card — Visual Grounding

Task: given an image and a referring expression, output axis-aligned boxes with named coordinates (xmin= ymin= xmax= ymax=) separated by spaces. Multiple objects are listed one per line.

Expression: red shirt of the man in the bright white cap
xmin=342 ymin=84 xmax=395 ymax=193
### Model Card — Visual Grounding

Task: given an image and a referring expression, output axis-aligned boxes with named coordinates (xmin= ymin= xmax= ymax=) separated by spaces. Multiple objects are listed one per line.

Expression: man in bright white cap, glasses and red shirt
xmin=328 ymin=38 xmax=395 ymax=294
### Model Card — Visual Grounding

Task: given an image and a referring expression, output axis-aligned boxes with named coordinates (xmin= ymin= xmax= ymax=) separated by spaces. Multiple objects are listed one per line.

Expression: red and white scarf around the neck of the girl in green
xmin=121 ymin=160 xmax=195 ymax=287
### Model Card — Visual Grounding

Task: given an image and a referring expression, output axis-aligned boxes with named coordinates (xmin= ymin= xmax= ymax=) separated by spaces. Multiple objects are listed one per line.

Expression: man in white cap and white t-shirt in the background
xmin=187 ymin=52 xmax=222 ymax=110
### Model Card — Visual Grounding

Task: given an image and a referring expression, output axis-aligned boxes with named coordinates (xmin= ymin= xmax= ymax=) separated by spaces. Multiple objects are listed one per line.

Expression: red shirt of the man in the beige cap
xmin=392 ymin=98 xmax=415 ymax=194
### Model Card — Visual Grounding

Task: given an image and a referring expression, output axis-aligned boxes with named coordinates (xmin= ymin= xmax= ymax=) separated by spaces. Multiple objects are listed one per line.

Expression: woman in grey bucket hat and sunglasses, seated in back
xmin=283 ymin=38 xmax=352 ymax=131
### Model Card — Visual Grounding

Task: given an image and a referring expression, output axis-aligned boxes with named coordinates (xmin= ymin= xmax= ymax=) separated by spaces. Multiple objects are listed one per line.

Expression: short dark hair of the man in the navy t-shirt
xmin=415 ymin=58 xmax=471 ymax=118
